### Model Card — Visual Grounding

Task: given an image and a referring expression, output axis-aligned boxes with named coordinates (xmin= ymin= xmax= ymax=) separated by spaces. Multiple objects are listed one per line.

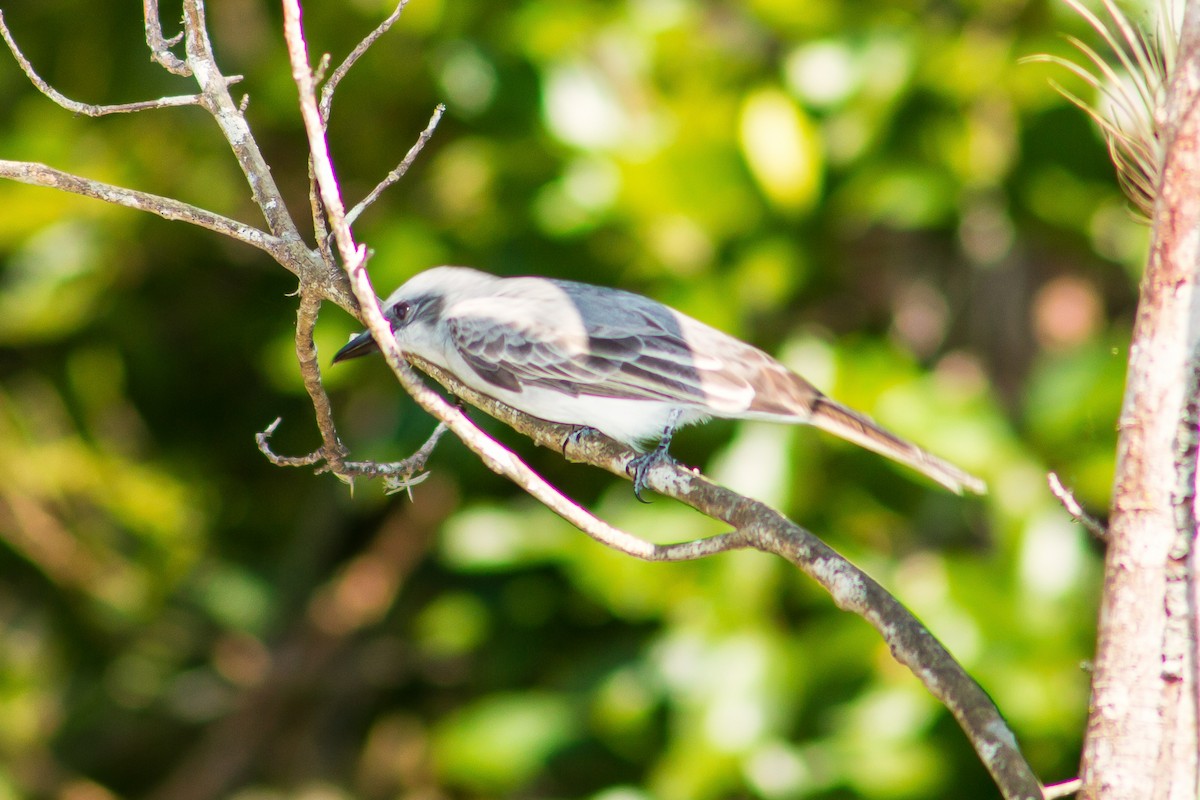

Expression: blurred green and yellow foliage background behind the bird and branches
xmin=0 ymin=0 xmax=1147 ymax=800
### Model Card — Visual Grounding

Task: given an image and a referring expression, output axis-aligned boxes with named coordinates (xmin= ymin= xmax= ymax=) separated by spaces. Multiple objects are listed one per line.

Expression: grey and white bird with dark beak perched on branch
xmin=334 ymin=266 xmax=986 ymax=499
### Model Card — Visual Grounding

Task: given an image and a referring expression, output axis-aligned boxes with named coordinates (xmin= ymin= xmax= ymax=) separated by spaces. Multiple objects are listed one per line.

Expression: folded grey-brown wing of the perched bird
xmin=446 ymin=293 xmax=754 ymax=408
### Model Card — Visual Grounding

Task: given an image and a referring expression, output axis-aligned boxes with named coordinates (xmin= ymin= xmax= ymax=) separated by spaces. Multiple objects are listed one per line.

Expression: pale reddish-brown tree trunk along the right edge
xmin=1080 ymin=2 xmax=1200 ymax=800
